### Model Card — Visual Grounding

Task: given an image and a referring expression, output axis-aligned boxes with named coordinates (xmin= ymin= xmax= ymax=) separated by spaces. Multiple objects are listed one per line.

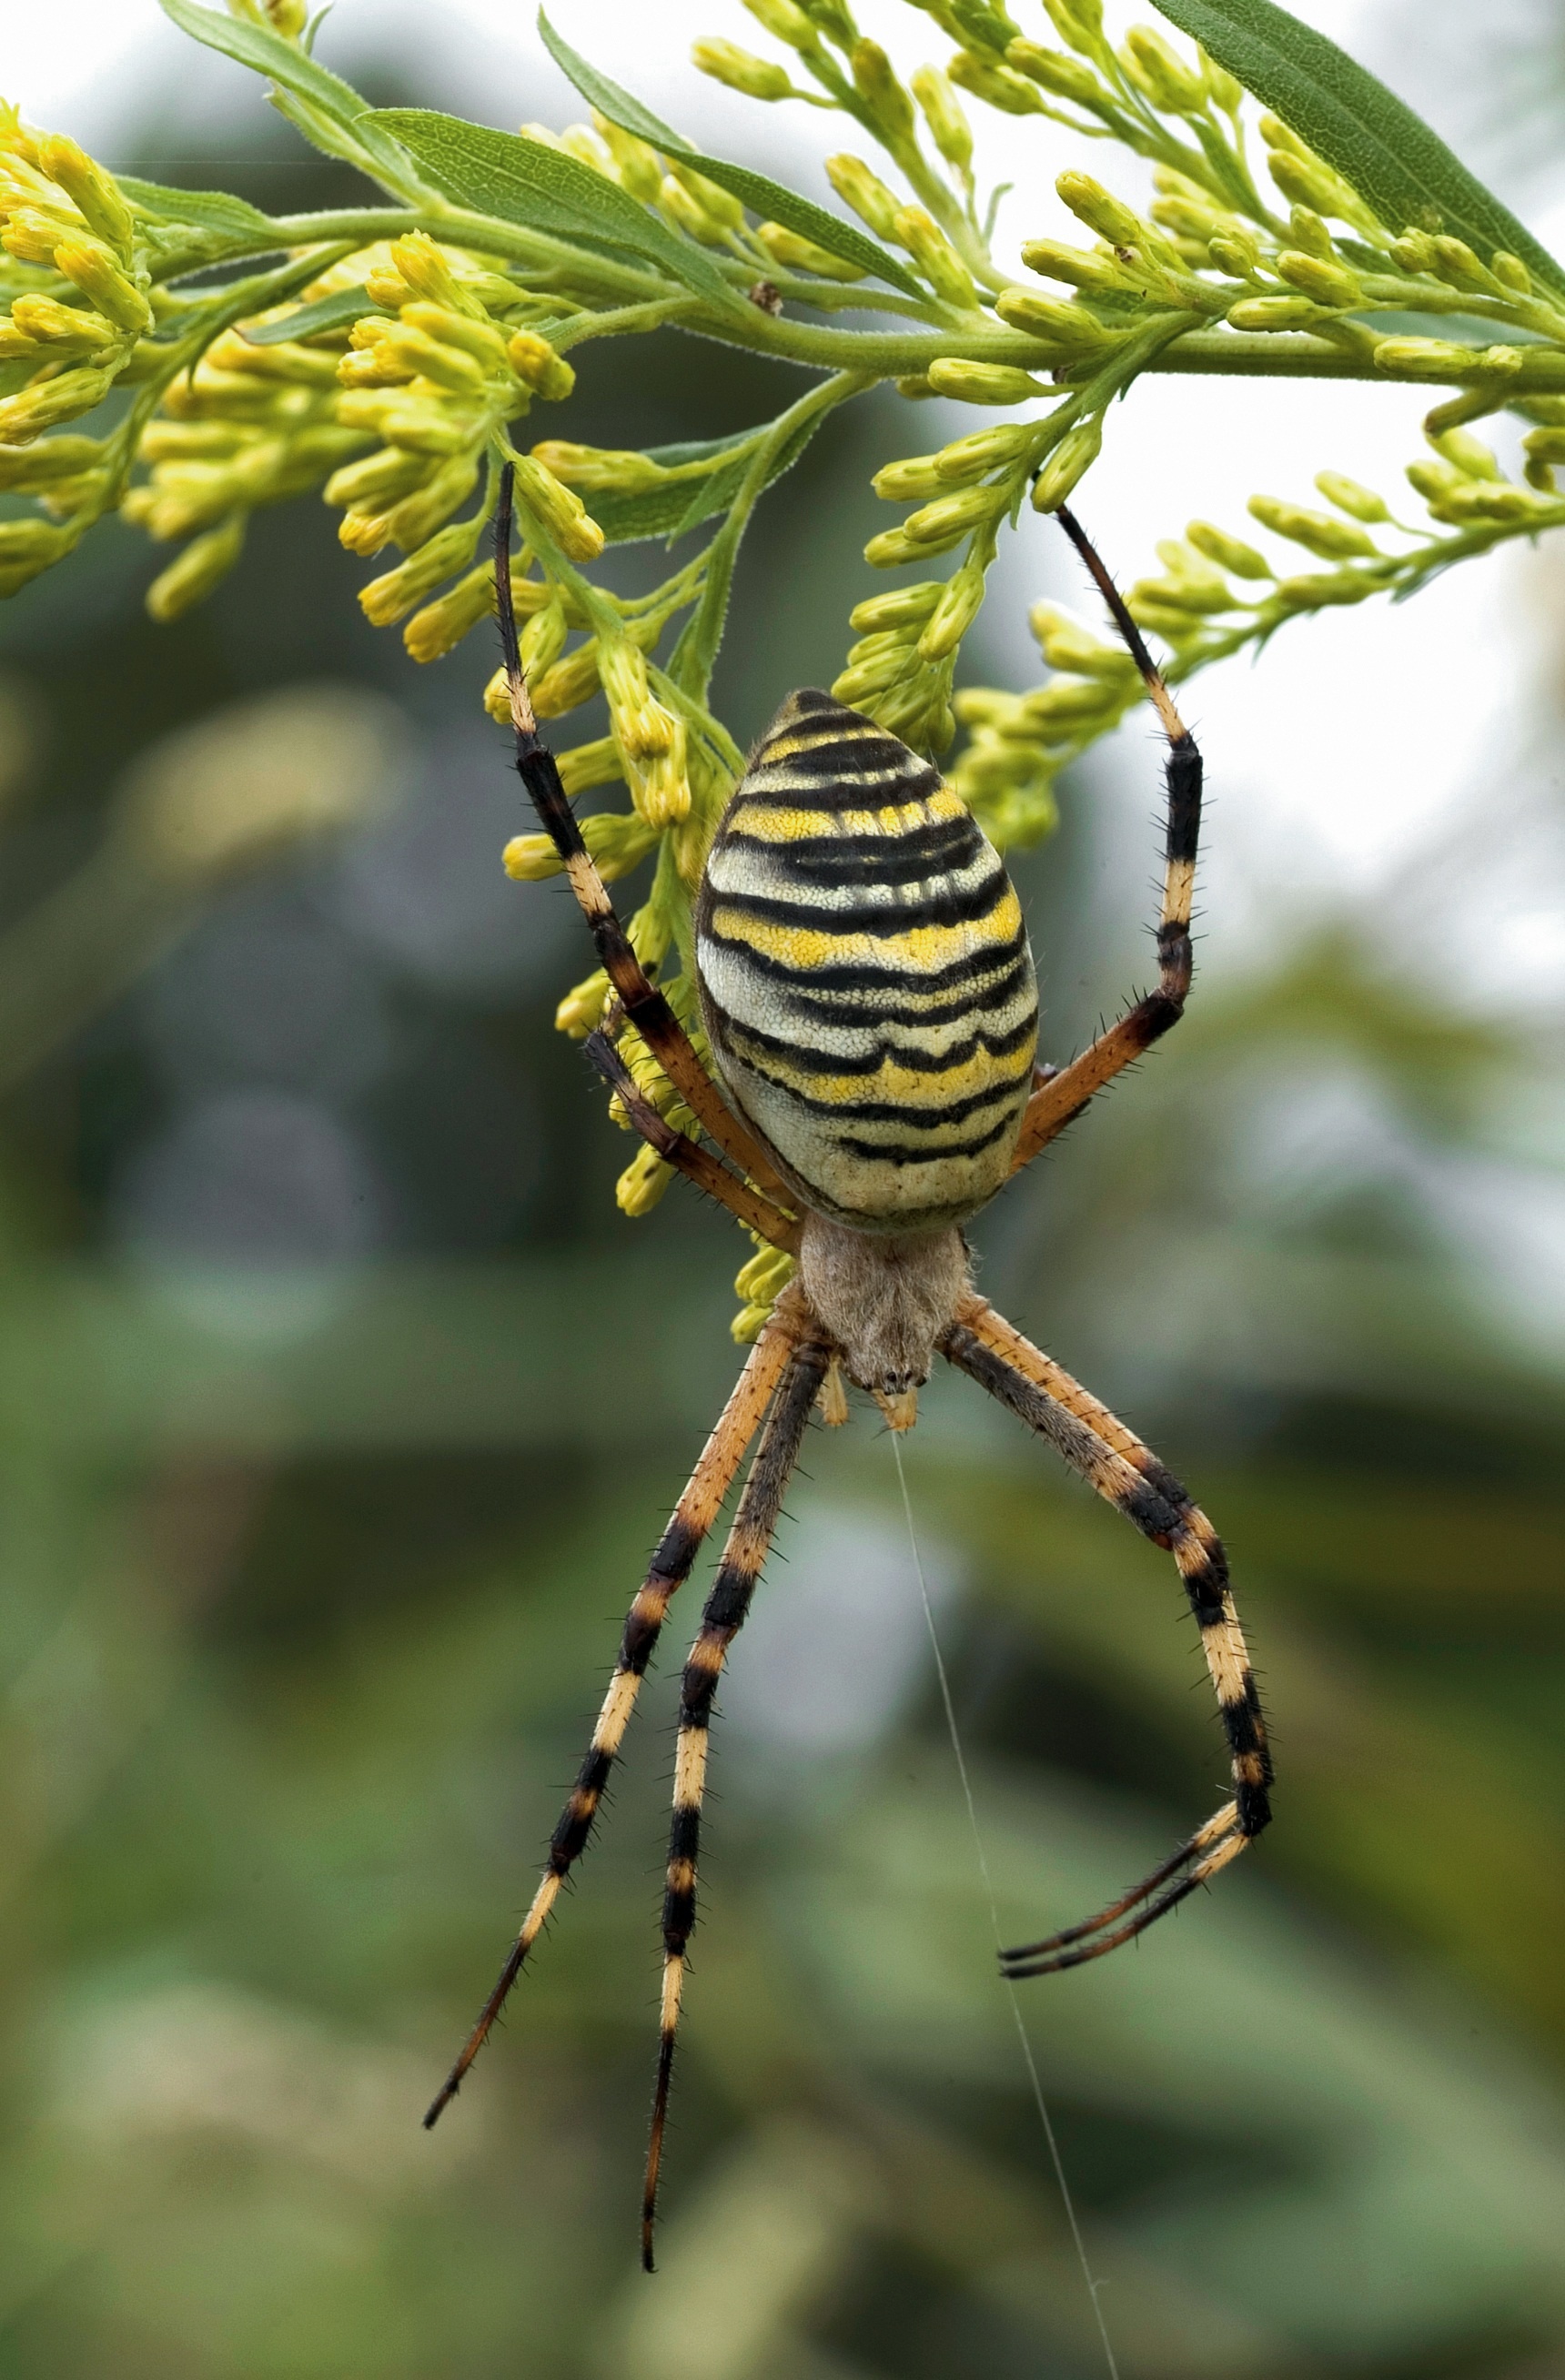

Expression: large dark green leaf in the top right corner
xmin=1157 ymin=0 xmax=1565 ymax=293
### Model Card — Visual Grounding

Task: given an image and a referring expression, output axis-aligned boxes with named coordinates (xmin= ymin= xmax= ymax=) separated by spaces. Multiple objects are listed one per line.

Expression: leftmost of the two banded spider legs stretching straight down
xmin=424 ymin=1290 xmax=803 ymax=2128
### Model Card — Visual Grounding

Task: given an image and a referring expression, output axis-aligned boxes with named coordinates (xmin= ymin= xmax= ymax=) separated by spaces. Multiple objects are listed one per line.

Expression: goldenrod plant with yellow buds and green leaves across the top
xmin=0 ymin=0 xmax=1565 ymax=1336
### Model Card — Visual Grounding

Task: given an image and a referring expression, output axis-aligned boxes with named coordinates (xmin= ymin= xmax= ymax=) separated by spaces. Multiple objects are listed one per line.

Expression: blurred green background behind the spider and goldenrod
xmin=0 ymin=9 xmax=1565 ymax=2380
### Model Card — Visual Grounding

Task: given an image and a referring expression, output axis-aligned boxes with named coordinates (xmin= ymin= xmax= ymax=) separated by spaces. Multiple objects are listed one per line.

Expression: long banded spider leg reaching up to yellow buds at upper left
xmin=496 ymin=464 xmax=783 ymax=1193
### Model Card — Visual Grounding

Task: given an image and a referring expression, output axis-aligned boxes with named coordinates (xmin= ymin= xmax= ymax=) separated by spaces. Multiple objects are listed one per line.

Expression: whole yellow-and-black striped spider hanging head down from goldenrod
xmin=424 ymin=467 xmax=1272 ymax=2273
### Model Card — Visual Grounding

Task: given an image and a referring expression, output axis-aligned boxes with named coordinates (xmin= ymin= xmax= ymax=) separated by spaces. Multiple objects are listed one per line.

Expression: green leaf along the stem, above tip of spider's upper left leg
xmin=367 ymin=107 xmax=743 ymax=312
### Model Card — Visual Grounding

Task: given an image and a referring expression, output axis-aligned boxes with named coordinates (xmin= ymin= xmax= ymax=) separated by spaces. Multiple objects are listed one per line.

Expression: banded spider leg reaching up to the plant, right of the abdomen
xmin=1010 ymin=505 xmax=1200 ymax=1174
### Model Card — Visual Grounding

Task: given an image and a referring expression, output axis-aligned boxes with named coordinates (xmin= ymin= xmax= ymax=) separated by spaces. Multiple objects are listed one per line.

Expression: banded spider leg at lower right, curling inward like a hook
xmin=941 ymin=1297 xmax=1272 ymax=1981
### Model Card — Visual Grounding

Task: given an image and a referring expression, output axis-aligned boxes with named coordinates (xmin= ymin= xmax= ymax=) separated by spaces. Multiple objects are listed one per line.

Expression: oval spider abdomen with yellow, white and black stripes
xmin=695 ymin=688 xmax=1038 ymax=1233
